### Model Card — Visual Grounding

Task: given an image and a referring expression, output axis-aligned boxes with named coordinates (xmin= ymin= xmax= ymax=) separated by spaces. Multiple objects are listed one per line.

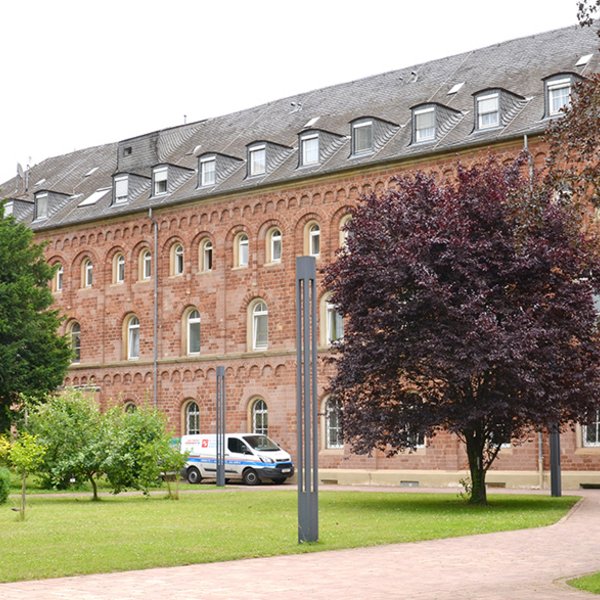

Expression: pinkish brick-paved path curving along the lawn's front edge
xmin=0 ymin=490 xmax=600 ymax=600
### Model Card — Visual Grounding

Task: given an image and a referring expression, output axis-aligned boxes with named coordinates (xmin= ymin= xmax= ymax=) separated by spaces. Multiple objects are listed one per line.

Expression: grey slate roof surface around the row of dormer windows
xmin=0 ymin=26 xmax=600 ymax=229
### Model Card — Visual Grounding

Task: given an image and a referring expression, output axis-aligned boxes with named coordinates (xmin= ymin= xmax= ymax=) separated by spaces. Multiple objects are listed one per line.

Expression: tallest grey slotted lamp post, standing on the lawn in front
xmin=296 ymin=256 xmax=319 ymax=543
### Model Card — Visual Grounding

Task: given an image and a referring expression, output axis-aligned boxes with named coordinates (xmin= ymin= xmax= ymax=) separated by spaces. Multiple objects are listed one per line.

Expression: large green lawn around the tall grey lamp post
xmin=0 ymin=487 xmax=577 ymax=581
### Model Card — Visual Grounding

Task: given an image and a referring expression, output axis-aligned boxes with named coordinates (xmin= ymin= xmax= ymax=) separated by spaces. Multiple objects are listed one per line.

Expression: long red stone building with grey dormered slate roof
xmin=0 ymin=27 xmax=600 ymax=487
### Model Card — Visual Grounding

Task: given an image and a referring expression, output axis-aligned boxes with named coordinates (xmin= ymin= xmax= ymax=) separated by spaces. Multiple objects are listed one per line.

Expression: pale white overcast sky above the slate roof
xmin=0 ymin=0 xmax=577 ymax=182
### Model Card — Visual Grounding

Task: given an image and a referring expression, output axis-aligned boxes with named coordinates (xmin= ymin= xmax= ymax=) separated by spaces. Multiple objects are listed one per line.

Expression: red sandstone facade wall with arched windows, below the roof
xmin=39 ymin=142 xmax=600 ymax=486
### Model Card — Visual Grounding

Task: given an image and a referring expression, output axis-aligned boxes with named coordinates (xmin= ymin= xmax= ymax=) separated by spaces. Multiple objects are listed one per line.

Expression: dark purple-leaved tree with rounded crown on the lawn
xmin=325 ymin=157 xmax=600 ymax=503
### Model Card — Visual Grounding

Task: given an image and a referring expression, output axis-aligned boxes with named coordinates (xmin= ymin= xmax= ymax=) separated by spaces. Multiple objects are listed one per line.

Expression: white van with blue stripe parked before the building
xmin=181 ymin=433 xmax=294 ymax=485
